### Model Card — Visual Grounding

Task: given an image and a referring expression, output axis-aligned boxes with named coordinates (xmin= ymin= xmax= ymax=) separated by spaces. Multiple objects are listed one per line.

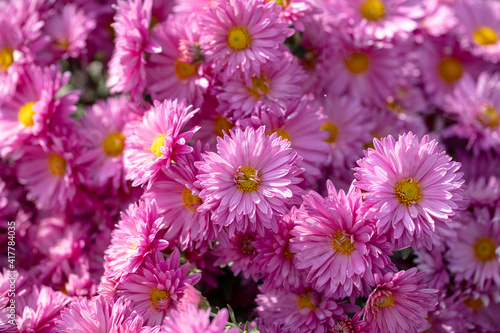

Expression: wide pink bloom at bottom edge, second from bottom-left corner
xmin=55 ymin=296 xmax=143 ymax=333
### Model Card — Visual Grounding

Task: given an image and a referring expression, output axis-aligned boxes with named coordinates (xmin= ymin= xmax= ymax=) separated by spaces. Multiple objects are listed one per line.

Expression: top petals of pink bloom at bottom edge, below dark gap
xmin=160 ymin=306 xmax=240 ymax=333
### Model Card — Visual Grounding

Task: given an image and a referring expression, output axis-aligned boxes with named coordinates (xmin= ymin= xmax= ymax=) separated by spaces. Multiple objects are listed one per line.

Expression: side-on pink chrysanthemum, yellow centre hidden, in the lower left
xmin=104 ymin=200 xmax=168 ymax=281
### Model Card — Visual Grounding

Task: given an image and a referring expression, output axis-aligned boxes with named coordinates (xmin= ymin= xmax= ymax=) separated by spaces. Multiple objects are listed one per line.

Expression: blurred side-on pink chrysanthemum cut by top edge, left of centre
xmin=107 ymin=0 xmax=161 ymax=99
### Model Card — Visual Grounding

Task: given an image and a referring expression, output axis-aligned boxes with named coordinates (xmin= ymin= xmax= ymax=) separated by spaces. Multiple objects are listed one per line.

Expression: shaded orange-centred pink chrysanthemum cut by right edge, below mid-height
xmin=446 ymin=207 xmax=500 ymax=291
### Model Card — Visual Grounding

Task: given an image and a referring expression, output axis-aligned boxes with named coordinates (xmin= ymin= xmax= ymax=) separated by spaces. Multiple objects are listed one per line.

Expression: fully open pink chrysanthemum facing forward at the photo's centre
xmin=195 ymin=127 xmax=303 ymax=236
